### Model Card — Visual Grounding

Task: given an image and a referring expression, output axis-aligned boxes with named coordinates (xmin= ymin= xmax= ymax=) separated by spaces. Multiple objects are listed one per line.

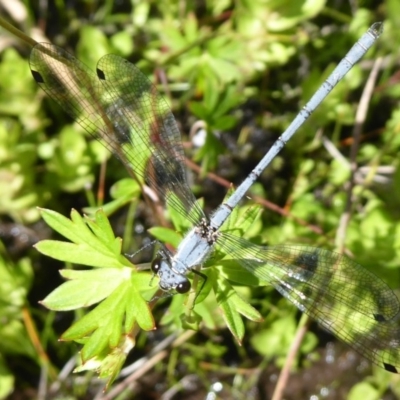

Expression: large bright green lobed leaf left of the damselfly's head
xmin=36 ymin=210 xmax=157 ymax=384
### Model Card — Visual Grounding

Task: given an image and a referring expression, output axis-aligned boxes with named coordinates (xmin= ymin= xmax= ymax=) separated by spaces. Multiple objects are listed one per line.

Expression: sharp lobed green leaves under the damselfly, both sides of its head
xmin=35 ymin=203 xmax=262 ymax=385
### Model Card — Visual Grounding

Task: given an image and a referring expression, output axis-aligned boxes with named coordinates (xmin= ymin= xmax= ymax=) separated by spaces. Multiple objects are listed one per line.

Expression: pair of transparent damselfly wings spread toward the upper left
xmin=30 ymin=43 xmax=204 ymax=224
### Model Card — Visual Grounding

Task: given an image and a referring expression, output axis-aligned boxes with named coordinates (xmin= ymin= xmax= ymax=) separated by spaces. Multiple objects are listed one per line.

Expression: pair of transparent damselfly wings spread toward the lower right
xmin=219 ymin=234 xmax=400 ymax=373
